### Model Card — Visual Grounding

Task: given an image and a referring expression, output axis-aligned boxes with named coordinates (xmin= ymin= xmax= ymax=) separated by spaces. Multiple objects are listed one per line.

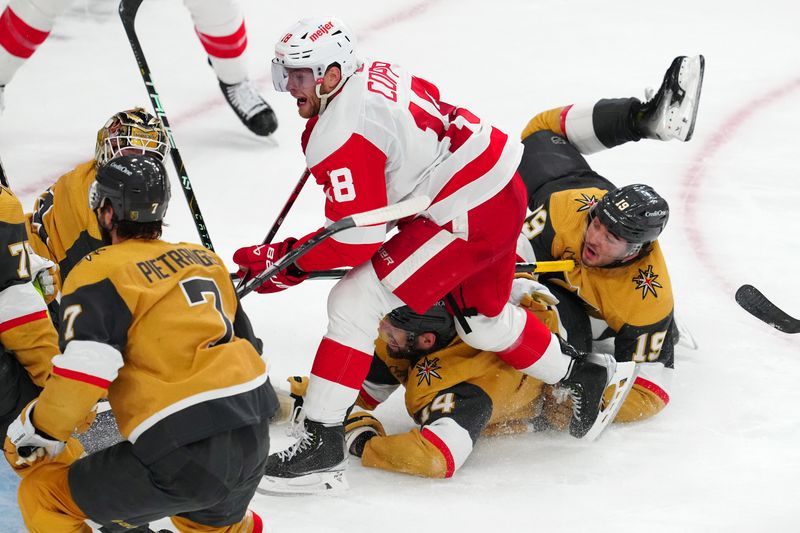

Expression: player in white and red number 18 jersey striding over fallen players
xmin=234 ymin=17 xmax=636 ymax=492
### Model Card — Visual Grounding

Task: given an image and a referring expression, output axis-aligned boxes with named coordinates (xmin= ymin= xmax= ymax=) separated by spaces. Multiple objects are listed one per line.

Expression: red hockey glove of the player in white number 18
xmin=233 ymin=238 xmax=308 ymax=294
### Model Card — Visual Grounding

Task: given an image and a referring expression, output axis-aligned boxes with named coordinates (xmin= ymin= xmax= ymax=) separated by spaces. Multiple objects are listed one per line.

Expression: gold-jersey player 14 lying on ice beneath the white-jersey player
xmin=282 ymin=278 xmax=608 ymax=478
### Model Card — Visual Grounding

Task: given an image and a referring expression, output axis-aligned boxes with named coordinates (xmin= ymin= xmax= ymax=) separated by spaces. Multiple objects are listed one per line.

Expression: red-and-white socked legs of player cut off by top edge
xmin=0 ymin=0 xmax=278 ymax=136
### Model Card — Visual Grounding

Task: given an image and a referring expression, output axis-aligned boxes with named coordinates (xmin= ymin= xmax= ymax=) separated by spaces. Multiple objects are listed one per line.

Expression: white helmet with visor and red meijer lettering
xmin=272 ymin=17 xmax=358 ymax=92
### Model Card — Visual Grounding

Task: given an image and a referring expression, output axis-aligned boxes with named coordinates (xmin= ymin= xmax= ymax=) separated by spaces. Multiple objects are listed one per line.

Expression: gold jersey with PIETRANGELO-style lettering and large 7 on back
xmin=34 ymin=239 xmax=277 ymax=461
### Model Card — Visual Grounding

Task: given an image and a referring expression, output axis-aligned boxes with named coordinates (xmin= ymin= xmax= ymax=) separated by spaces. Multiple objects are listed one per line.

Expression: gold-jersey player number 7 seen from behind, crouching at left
xmin=7 ymin=156 xmax=277 ymax=533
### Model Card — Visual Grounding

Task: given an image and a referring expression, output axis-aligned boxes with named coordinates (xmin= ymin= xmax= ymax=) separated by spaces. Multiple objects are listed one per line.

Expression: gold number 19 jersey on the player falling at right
xmin=518 ymin=107 xmax=675 ymax=422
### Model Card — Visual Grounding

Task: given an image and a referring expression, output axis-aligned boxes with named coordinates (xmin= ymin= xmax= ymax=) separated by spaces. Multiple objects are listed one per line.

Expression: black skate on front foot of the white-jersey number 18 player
xmin=257 ymin=419 xmax=348 ymax=494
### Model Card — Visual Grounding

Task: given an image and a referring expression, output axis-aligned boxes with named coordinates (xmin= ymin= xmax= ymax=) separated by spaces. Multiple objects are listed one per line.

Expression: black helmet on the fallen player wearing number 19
xmin=591 ymin=183 xmax=669 ymax=245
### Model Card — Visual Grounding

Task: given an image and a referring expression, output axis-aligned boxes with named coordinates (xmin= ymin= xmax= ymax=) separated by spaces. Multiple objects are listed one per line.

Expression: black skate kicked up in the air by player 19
xmin=638 ymin=55 xmax=705 ymax=141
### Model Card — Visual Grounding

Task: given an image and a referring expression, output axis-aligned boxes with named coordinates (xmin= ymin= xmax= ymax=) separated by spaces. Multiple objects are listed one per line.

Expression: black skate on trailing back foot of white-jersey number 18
xmin=559 ymin=343 xmax=638 ymax=441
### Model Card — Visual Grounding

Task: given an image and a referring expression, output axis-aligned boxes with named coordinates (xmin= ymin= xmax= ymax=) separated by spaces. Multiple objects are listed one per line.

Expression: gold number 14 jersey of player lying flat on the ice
xmin=357 ymin=338 xmax=543 ymax=477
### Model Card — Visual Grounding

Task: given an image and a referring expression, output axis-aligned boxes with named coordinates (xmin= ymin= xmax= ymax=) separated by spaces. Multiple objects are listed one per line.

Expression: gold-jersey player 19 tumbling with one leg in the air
xmin=518 ymin=56 xmax=704 ymax=422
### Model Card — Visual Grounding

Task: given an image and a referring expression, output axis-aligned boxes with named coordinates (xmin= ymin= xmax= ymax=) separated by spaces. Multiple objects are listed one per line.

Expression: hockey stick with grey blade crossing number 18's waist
xmin=236 ymin=196 xmax=431 ymax=298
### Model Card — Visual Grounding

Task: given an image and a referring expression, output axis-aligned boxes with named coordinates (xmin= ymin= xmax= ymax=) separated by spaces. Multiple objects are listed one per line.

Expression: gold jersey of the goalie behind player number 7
xmin=30 ymin=159 xmax=103 ymax=288
